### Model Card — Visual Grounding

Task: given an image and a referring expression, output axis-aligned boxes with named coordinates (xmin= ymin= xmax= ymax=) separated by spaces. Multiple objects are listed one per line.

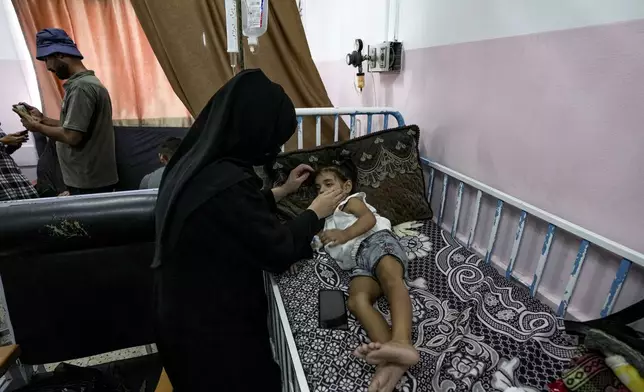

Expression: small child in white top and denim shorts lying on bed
xmin=315 ymin=165 xmax=426 ymax=392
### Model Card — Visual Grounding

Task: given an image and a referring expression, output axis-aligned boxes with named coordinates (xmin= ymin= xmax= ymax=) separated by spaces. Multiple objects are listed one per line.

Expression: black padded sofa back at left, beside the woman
xmin=0 ymin=190 xmax=156 ymax=364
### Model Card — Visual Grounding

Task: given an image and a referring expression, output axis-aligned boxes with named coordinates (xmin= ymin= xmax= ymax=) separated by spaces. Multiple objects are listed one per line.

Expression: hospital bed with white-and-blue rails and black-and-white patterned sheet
xmin=266 ymin=108 xmax=644 ymax=392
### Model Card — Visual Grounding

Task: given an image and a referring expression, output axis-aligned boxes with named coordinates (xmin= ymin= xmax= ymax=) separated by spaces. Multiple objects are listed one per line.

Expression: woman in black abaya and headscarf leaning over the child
xmin=153 ymin=70 xmax=342 ymax=392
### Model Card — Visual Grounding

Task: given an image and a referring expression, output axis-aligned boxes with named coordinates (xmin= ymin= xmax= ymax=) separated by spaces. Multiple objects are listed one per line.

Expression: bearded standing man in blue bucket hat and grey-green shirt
xmin=22 ymin=28 xmax=118 ymax=195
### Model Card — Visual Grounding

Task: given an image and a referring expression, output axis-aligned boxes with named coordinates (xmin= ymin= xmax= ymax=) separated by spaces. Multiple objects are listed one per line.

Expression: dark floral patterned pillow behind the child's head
xmin=259 ymin=125 xmax=432 ymax=225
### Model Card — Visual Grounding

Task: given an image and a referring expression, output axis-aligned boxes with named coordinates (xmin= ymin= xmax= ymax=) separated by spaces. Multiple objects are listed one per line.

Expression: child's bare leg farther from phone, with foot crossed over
xmin=367 ymin=256 xmax=419 ymax=366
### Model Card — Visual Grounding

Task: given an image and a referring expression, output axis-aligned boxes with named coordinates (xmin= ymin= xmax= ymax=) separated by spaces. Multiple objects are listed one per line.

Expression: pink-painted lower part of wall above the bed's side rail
xmin=317 ymin=20 xmax=644 ymax=313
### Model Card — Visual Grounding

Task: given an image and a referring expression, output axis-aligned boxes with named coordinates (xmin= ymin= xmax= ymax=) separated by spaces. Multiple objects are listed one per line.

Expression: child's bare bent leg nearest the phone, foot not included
xmin=347 ymin=276 xmax=391 ymax=344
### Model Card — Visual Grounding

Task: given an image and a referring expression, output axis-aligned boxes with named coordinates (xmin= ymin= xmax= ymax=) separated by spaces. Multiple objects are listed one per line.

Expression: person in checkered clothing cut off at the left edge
xmin=0 ymin=125 xmax=38 ymax=201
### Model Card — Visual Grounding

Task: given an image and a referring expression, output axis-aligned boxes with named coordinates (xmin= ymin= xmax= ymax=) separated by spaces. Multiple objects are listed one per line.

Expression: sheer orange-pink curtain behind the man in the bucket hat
xmin=13 ymin=0 xmax=192 ymax=126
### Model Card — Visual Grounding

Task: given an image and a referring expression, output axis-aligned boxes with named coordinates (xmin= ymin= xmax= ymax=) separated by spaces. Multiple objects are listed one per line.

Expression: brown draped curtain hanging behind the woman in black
xmin=131 ymin=0 xmax=349 ymax=147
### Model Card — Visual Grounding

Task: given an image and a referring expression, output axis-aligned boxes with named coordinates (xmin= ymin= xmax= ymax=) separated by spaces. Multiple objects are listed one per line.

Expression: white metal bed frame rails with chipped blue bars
xmin=265 ymin=108 xmax=644 ymax=392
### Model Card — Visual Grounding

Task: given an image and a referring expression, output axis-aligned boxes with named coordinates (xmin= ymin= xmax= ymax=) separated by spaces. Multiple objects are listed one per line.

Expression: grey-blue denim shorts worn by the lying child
xmin=351 ymin=230 xmax=409 ymax=280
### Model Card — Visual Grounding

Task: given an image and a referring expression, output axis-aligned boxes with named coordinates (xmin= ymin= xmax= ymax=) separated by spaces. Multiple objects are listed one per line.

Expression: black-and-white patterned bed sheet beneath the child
xmin=276 ymin=221 xmax=580 ymax=392
